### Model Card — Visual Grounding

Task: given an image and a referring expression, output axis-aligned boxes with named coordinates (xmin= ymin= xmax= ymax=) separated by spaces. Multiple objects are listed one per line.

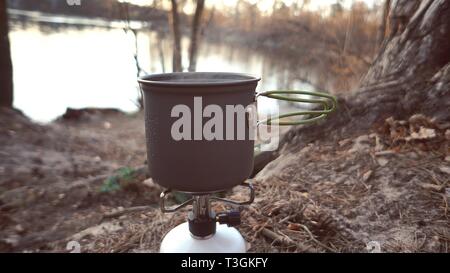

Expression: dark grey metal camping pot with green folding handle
xmin=139 ymin=72 xmax=336 ymax=194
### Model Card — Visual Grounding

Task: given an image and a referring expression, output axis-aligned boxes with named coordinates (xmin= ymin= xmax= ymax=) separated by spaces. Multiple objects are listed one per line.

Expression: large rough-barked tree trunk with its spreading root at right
xmin=283 ymin=0 xmax=450 ymax=147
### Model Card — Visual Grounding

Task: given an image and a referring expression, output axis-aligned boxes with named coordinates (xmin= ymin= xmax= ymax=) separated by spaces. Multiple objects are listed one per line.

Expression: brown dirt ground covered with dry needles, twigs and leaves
xmin=0 ymin=109 xmax=450 ymax=252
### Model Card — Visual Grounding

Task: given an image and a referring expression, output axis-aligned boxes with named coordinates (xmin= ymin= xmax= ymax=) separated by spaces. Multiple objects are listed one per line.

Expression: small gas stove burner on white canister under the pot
xmin=160 ymin=183 xmax=255 ymax=253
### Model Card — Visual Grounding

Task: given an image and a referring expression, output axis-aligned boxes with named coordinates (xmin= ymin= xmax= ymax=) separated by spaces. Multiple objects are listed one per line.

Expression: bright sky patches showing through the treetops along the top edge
xmin=122 ymin=0 xmax=379 ymax=13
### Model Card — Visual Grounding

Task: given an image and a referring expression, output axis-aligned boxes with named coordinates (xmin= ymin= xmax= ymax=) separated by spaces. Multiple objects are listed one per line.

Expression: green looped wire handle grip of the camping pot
xmin=257 ymin=90 xmax=337 ymax=126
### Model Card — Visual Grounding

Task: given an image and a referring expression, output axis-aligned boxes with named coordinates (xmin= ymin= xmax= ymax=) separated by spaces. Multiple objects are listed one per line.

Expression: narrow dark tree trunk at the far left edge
xmin=0 ymin=0 xmax=13 ymax=108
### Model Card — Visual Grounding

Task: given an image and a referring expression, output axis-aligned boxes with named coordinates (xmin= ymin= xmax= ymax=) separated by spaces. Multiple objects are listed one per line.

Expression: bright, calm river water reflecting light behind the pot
xmin=10 ymin=11 xmax=320 ymax=122
